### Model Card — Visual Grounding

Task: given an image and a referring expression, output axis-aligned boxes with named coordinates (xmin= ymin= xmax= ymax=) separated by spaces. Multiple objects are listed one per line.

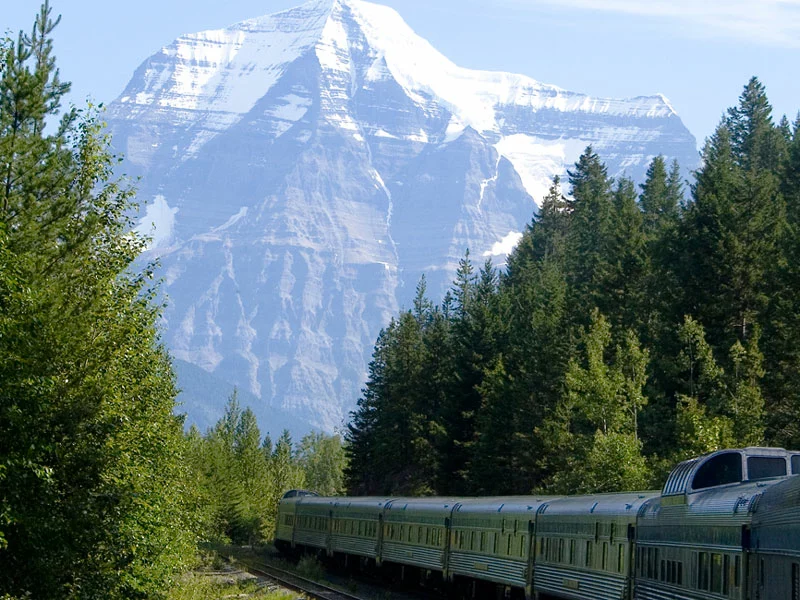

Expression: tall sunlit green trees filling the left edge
xmin=0 ymin=3 xmax=194 ymax=598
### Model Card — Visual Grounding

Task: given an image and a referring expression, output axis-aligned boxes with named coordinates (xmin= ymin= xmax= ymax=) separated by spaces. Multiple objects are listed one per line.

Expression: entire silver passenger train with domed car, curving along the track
xmin=275 ymin=448 xmax=800 ymax=600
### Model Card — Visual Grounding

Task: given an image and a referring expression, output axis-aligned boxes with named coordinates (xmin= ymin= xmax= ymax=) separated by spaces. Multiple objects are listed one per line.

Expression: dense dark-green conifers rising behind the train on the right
xmin=347 ymin=78 xmax=800 ymax=495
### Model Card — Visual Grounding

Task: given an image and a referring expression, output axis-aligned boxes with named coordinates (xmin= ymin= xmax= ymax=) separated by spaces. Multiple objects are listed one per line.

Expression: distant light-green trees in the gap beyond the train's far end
xmin=186 ymin=392 xmax=345 ymax=545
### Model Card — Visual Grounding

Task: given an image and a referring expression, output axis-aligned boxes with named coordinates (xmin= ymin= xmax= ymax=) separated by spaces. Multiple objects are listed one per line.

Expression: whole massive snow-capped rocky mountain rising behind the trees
xmin=104 ymin=0 xmax=697 ymax=429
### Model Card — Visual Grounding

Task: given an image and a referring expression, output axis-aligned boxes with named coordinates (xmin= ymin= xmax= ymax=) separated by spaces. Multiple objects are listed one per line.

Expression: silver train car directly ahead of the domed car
xmin=533 ymin=492 xmax=658 ymax=600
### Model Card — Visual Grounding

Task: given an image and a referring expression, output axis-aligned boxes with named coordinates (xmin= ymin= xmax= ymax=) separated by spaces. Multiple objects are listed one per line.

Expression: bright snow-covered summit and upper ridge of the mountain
xmin=120 ymin=0 xmax=674 ymax=131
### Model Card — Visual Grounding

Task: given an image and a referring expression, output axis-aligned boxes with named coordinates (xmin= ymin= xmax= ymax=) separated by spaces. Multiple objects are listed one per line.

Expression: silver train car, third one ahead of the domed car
xmin=380 ymin=498 xmax=456 ymax=576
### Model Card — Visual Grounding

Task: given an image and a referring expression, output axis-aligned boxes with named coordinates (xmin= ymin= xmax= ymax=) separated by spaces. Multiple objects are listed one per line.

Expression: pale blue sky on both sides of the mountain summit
xmin=6 ymin=0 xmax=800 ymax=143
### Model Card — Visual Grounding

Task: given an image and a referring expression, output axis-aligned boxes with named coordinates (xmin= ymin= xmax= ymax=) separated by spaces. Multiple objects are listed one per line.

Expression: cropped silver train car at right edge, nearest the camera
xmin=750 ymin=468 xmax=800 ymax=600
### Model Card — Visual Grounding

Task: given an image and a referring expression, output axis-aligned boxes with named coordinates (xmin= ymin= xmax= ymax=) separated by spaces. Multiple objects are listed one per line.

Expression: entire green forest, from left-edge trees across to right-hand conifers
xmin=0 ymin=4 xmax=800 ymax=600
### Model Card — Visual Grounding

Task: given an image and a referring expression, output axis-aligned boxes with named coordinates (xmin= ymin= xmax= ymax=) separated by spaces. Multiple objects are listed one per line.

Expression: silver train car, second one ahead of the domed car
xmin=447 ymin=496 xmax=552 ymax=597
